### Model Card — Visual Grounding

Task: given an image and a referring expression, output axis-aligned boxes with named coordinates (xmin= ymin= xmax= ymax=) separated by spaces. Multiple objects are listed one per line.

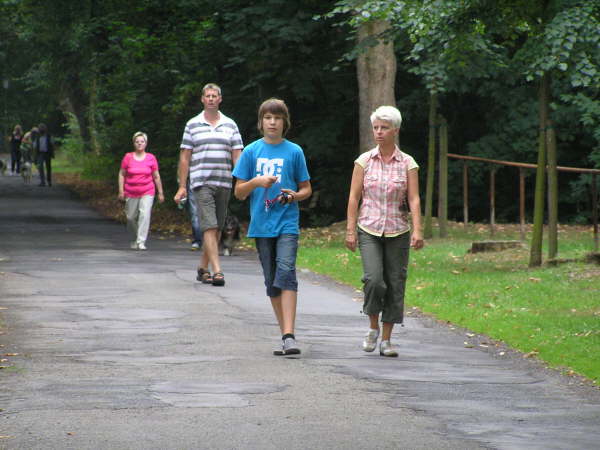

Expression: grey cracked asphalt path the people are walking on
xmin=0 ymin=171 xmax=600 ymax=450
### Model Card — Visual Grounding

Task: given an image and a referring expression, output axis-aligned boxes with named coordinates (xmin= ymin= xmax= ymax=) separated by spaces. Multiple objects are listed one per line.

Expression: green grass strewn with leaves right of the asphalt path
xmin=298 ymin=224 xmax=600 ymax=383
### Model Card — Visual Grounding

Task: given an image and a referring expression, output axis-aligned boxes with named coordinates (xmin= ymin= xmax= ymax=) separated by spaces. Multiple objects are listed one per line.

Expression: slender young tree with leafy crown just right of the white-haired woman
xmin=330 ymin=0 xmax=501 ymax=238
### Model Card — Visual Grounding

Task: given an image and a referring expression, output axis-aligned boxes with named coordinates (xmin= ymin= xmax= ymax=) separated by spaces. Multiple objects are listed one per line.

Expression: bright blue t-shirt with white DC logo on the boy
xmin=233 ymin=139 xmax=310 ymax=237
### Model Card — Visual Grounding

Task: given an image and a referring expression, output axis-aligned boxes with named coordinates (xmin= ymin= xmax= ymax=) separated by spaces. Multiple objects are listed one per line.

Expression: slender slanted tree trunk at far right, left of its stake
xmin=529 ymin=75 xmax=548 ymax=267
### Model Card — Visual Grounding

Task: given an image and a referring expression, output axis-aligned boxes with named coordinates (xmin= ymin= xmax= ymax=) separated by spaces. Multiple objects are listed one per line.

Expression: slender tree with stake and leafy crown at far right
xmin=508 ymin=0 xmax=600 ymax=266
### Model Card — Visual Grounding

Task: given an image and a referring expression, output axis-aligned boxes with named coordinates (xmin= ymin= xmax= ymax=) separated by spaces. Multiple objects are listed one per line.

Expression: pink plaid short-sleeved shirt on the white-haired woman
xmin=355 ymin=146 xmax=419 ymax=237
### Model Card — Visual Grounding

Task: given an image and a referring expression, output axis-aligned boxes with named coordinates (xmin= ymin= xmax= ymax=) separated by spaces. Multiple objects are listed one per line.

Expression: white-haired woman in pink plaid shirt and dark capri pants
xmin=346 ymin=106 xmax=423 ymax=356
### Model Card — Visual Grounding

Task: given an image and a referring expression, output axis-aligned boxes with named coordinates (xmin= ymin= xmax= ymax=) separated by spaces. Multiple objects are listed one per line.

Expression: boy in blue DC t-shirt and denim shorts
xmin=233 ymin=98 xmax=312 ymax=355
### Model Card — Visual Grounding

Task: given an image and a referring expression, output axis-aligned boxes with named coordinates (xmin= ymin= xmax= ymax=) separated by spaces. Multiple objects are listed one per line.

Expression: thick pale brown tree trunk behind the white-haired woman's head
xmin=356 ymin=20 xmax=396 ymax=154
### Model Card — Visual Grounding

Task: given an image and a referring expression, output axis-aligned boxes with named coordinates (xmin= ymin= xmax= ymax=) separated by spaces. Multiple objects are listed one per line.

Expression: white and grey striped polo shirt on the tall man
xmin=181 ymin=111 xmax=244 ymax=189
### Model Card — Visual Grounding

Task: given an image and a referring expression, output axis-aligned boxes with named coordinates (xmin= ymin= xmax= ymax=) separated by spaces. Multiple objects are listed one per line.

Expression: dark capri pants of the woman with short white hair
xmin=358 ymin=229 xmax=410 ymax=323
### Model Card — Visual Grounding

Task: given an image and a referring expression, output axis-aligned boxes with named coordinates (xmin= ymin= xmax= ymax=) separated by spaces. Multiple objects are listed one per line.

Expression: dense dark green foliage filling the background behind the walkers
xmin=0 ymin=0 xmax=600 ymax=224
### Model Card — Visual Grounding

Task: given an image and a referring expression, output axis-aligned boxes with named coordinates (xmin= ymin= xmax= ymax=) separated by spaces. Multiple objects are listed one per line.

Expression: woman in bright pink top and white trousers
xmin=119 ymin=131 xmax=165 ymax=250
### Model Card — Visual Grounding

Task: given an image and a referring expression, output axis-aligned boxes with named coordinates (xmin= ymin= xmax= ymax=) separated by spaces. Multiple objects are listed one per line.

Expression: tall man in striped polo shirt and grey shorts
xmin=175 ymin=83 xmax=244 ymax=286
